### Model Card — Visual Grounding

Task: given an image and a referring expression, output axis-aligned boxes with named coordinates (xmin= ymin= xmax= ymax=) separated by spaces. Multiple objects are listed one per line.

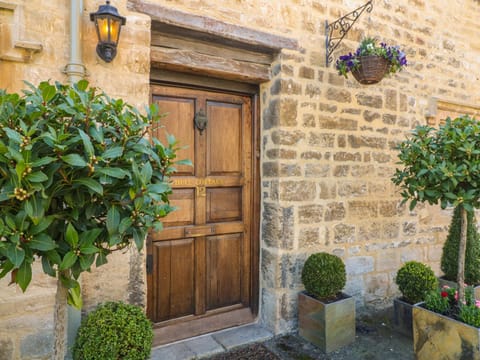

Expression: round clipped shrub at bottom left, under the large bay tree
xmin=73 ymin=302 xmax=153 ymax=360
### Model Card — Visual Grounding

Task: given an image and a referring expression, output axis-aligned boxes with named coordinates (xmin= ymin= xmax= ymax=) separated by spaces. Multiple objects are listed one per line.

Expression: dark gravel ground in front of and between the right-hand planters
xmin=203 ymin=309 xmax=412 ymax=360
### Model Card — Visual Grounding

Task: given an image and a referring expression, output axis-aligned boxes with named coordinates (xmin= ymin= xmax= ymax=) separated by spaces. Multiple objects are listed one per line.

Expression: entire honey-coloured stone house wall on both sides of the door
xmin=0 ymin=0 xmax=480 ymax=359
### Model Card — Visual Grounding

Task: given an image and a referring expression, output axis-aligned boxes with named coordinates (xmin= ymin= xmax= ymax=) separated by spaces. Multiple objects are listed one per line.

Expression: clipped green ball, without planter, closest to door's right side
xmin=302 ymin=252 xmax=347 ymax=299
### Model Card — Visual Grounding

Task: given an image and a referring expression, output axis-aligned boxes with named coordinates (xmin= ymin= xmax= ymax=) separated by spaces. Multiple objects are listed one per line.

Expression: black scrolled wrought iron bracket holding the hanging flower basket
xmin=325 ymin=0 xmax=373 ymax=67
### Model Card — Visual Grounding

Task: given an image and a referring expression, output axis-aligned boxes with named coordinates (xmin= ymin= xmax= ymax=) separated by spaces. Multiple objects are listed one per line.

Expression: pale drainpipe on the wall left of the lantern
xmin=65 ymin=0 xmax=86 ymax=85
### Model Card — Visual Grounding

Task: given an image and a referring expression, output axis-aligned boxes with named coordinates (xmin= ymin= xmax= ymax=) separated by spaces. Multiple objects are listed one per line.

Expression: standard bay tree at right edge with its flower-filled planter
xmin=392 ymin=115 xmax=480 ymax=360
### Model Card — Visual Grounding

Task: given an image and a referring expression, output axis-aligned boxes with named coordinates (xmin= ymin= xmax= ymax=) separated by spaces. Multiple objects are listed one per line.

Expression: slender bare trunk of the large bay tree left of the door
xmin=53 ymin=277 xmax=68 ymax=360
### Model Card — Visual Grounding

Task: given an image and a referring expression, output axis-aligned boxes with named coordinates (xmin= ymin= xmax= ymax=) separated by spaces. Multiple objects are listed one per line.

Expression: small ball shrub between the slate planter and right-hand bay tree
xmin=395 ymin=261 xmax=438 ymax=304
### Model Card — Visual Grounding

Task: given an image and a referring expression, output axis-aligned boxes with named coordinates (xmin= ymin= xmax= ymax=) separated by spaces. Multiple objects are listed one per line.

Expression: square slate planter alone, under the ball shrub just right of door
xmin=298 ymin=292 xmax=355 ymax=353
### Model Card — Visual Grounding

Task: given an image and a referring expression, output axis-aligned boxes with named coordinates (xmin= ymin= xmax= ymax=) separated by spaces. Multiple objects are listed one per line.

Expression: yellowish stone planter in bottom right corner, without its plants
xmin=413 ymin=303 xmax=480 ymax=360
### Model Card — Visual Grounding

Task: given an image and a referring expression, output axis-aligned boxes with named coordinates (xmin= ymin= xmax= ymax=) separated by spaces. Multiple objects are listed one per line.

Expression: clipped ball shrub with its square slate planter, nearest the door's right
xmin=298 ymin=252 xmax=355 ymax=353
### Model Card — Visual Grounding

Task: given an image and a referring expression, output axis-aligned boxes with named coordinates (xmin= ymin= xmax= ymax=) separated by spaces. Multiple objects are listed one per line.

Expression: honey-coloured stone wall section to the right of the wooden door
xmin=144 ymin=0 xmax=480 ymax=332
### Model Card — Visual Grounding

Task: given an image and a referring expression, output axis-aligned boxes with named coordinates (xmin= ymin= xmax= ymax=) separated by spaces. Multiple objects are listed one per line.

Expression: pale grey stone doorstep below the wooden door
xmin=150 ymin=324 xmax=273 ymax=360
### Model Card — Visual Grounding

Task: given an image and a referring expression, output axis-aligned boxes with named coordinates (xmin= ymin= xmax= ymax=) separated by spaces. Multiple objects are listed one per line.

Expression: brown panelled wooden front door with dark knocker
xmin=147 ymin=85 xmax=258 ymax=345
